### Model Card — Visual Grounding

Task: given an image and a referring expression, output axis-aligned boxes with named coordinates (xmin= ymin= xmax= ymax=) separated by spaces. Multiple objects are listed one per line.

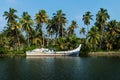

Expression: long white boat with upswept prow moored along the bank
xmin=26 ymin=44 xmax=81 ymax=56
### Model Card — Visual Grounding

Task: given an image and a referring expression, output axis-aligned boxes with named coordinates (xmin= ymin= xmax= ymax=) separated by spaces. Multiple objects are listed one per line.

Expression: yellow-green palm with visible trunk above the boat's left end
xmin=20 ymin=12 xmax=33 ymax=46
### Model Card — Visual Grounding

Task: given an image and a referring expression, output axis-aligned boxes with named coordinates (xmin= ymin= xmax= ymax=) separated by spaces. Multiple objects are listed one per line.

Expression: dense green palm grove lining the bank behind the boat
xmin=0 ymin=8 xmax=120 ymax=55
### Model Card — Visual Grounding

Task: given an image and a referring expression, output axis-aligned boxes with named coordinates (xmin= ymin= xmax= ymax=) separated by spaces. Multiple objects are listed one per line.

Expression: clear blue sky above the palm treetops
xmin=0 ymin=0 xmax=120 ymax=34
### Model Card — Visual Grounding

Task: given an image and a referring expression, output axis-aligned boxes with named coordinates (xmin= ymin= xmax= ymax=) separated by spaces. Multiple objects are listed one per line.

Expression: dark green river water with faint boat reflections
xmin=0 ymin=57 xmax=120 ymax=80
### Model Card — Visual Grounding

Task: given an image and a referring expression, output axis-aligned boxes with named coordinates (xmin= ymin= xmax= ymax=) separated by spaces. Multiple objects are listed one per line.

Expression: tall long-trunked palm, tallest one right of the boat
xmin=96 ymin=8 xmax=110 ymax=48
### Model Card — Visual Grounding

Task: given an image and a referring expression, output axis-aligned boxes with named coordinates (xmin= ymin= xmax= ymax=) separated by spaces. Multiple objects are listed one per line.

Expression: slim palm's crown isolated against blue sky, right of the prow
xmin=82 ymin=11 xmax=93 ymax=31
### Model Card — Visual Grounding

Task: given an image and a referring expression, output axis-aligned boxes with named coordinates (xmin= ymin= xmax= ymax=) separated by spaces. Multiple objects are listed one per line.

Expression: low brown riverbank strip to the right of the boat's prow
xmin=88 ymin=52 xmax=120 ymax=57
